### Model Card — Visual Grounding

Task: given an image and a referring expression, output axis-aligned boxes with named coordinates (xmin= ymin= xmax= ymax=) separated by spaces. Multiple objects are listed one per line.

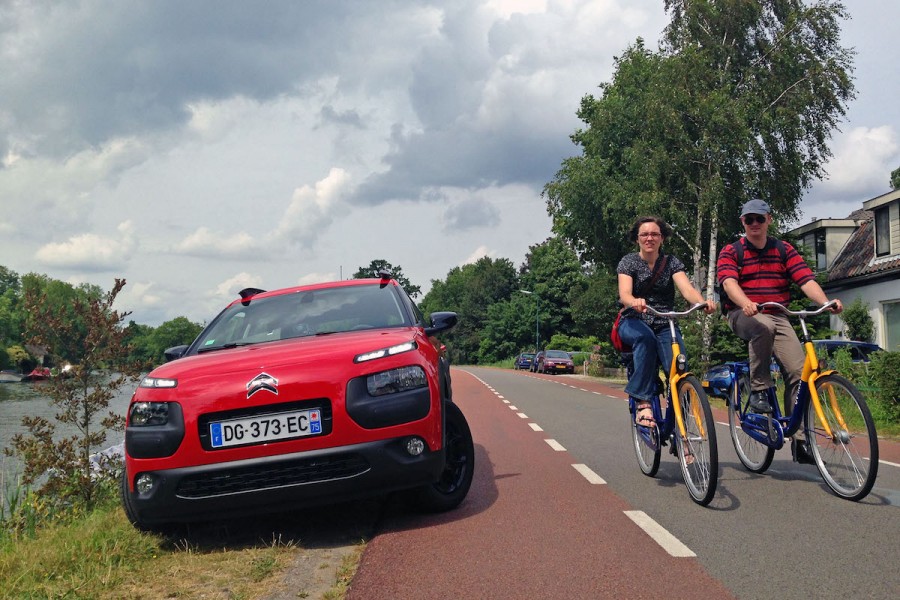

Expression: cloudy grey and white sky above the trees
xmin=0 ymin=0 xmax=900 ymax=325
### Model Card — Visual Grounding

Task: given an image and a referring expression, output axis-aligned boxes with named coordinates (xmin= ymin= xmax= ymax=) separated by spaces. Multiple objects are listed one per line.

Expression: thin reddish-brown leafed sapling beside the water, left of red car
xmin=4 ymin=279 xmax=137 ymax=509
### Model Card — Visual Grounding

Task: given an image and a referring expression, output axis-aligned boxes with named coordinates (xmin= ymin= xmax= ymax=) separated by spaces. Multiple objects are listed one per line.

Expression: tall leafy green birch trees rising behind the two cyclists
xmin=544 ymin=0 xmax=854 ymax=360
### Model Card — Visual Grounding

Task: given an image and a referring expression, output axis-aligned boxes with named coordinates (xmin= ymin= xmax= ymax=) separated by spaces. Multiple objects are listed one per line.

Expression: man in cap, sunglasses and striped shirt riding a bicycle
xmin=716 ymin=200 xmax=843 ymax=464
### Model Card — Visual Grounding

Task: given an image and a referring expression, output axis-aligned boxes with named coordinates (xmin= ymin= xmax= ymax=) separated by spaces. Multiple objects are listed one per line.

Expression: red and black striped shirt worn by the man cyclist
xmin=716 ymin=237 xmax=815 ymax=310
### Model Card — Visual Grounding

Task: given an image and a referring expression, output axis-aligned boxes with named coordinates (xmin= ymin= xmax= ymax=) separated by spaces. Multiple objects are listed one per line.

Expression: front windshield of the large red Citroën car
xmin=194 ymin=284 xmax=413 ymax=352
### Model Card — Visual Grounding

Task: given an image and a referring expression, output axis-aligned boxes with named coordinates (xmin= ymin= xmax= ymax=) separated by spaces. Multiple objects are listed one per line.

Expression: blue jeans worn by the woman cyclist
xmin=619 ymin=319 xmax=687 ymax=401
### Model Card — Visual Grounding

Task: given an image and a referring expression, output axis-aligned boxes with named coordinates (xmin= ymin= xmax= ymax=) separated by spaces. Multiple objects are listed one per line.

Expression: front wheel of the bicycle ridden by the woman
xmin=675 ymin=375 xmax=719 ymax=506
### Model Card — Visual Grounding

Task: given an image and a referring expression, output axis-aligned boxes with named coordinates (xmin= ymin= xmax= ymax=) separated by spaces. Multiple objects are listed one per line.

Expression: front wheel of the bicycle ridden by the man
xmin=806 ymin=374 xmax=878 ymax=500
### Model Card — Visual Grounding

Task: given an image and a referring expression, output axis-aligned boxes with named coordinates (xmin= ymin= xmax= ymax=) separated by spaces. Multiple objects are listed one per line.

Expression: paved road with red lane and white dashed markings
xmin=348 ymin=368 xmax=900 ymax=600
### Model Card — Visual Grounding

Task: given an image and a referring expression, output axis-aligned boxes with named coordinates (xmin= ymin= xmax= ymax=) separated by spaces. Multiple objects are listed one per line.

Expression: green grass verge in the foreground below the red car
xmin=0 ymin=503 xmax=364 ymax=600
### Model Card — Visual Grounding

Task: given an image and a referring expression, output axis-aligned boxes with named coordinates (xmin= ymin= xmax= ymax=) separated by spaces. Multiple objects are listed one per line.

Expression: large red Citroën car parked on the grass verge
xmin=121 ymin=275 xmax=474 ymax=529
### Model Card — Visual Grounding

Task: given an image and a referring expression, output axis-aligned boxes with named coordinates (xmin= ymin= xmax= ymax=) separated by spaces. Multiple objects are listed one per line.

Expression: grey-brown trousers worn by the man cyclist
xmin=728 ymin=309 xmax=806 ymax=415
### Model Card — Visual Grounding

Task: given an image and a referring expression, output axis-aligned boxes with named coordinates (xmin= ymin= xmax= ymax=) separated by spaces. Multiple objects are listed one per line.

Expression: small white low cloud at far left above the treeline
xmin=35 ymin=221 xmax=137 ymax=271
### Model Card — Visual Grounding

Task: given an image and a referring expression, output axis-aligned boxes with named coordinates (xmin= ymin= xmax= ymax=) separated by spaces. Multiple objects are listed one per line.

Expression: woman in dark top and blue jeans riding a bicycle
xmin=616 ymin=216 xmax=716 ymax=427
